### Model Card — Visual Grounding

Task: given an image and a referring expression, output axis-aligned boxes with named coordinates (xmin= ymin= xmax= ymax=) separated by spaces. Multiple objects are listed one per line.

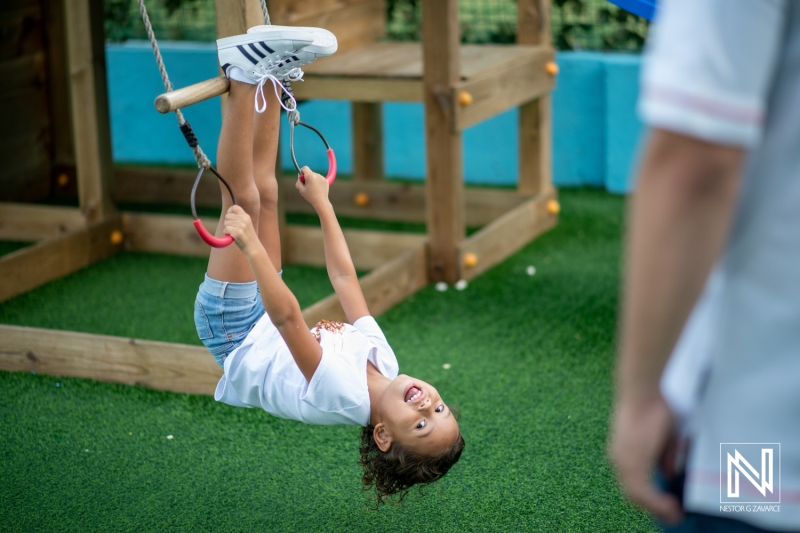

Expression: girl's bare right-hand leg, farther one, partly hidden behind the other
xmin=253 ymin=83 xmax=281 ymax=272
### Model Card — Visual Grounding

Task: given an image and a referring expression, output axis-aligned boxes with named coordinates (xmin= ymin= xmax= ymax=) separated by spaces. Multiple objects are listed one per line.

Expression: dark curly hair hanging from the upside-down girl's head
xmin=358 ymin=418 xmax=464 ymax=509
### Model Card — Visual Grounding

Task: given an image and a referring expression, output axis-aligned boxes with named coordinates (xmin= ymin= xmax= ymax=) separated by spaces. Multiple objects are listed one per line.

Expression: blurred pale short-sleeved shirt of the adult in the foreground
xmin=640 ymin=0 xmax=800 ymax=530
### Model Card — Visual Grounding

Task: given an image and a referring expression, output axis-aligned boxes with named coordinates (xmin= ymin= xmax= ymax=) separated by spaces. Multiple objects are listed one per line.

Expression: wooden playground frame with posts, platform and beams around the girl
xmin=0 ymin=0 xmax=558 ymax=394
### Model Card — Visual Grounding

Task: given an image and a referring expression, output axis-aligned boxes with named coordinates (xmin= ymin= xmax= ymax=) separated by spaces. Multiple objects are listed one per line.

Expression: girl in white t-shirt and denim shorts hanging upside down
xmin=195 ymin=26 xmax=464 ymax=503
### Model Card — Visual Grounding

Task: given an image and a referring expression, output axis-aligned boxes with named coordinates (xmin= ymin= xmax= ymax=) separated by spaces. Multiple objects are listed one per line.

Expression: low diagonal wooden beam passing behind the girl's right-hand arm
xmin=303 ymin=244 xmax=428 ymax=327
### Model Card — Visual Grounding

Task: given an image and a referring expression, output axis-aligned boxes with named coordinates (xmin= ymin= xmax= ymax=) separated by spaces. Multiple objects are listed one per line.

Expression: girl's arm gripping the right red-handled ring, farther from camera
xmin=296 ymin=167 xmax=369 ymax=324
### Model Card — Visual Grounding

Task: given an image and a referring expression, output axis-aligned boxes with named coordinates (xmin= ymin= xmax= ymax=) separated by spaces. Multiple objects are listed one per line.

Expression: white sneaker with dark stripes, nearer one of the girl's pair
xmin=217 ymin=26 xmax=316 ymax=83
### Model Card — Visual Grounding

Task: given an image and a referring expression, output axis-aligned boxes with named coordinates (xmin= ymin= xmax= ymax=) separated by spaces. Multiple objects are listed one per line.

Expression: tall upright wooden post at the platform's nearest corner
xmin=422 ymin=0 xmax=465 ymax=283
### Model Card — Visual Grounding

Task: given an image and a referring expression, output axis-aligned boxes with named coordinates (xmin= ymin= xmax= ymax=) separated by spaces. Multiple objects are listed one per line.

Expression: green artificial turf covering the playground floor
xmin=0 ymin=190 xmax=655 ymax=533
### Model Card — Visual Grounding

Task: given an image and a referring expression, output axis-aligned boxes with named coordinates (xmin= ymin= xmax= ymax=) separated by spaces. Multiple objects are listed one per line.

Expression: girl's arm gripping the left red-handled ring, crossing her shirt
xmin=225 ymin=205 xmax=322 ymax=382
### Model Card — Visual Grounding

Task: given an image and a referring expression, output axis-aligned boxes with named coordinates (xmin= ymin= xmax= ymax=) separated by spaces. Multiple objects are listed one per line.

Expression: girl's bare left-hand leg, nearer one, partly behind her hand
xmin=208 ymin=80 xmax=261 ymax=283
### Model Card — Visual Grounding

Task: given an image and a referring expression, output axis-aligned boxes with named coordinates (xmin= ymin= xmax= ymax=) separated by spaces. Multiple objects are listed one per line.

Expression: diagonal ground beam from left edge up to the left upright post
xmin=0 ymin=217 xmax=122 ymax=301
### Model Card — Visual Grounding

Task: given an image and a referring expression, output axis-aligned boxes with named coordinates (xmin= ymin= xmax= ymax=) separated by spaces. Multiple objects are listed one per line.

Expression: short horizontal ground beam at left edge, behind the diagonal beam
xmin=0 ymin=203 xmax=86 ymax=241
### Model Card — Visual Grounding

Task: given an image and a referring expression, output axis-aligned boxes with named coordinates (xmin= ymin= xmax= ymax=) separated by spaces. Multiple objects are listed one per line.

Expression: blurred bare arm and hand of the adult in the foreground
xmin=611 ymin=129 xmax=743 ymax=521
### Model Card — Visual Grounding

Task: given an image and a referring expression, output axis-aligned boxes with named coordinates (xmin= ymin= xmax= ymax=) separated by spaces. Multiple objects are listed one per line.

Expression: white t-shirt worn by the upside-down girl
xmin=214 ymin=313 xmax=398 ymax=426
